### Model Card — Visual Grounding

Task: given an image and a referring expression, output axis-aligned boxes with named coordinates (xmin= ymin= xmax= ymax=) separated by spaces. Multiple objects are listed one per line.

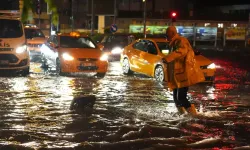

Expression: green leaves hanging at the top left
xmin=19 ymin=0 xmax=59 ymax=25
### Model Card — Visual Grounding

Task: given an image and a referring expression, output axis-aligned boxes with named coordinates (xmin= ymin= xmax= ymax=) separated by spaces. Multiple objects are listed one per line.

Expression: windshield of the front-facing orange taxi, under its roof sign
xmin=60 ymin=36 xmax=97 ymax=48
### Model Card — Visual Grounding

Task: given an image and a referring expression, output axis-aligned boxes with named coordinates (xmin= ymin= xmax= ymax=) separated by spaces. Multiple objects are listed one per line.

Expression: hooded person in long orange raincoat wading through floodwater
xmin=165 ymin=26 xmax=205 ymax=115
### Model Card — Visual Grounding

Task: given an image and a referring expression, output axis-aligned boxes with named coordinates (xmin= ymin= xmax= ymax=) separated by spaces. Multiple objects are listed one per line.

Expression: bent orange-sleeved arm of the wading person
xmin=165 ymin=39 xmax=188 ymax=62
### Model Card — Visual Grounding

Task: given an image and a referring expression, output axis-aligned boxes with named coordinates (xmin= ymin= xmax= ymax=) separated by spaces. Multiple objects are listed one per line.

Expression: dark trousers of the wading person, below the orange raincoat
xmin=173 ymin=87 xmax=191 ymax=108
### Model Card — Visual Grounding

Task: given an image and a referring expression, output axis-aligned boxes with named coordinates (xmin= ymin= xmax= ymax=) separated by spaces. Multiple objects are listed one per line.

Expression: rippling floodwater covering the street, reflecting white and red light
xmin=0 ymin=51 xmax=250 ymax=150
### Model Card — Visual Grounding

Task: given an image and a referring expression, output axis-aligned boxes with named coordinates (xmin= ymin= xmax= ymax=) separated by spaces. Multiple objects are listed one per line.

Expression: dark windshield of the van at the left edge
xmin=0 ymin=19 xmax=23 ymax=38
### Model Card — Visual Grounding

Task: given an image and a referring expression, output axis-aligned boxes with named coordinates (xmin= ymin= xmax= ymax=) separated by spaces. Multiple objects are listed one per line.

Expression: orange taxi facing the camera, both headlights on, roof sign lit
xmin=41 ymin=32 xmax=108 ymax=77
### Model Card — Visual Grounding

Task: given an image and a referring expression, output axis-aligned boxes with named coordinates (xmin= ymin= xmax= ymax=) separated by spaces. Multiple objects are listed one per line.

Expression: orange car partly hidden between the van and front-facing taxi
xmin=24 ymin=24 xmax=46 ymax=57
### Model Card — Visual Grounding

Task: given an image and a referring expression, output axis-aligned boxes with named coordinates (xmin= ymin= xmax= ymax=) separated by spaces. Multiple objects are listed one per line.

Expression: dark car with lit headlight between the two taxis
xmin=98 ymin=33 xmax=135 ymax=60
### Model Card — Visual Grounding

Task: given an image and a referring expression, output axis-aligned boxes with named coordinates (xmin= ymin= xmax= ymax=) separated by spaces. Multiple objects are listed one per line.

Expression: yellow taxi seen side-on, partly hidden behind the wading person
xmin=120 ymin=38 xmax=216 ymax=82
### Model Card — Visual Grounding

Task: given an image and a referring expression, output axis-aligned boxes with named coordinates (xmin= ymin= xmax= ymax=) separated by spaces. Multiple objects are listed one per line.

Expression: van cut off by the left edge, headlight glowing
xmin=0 ymin=11 xmax=30 ymax=76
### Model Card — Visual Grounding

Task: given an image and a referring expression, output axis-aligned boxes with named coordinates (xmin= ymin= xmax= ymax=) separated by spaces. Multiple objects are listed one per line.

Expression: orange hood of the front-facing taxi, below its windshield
xmin=59 ymin=48 xmax=102 ymax=59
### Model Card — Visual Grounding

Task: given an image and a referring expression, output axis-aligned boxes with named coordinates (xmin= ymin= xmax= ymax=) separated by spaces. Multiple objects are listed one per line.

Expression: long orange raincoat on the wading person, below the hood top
xmin=165 ymin=35 xmax=205 ymax=90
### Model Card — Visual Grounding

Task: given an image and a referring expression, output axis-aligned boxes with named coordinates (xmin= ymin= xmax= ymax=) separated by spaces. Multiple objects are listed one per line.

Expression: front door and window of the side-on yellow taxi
xmin=139 ymin=40 xmax=161 ymax=75
